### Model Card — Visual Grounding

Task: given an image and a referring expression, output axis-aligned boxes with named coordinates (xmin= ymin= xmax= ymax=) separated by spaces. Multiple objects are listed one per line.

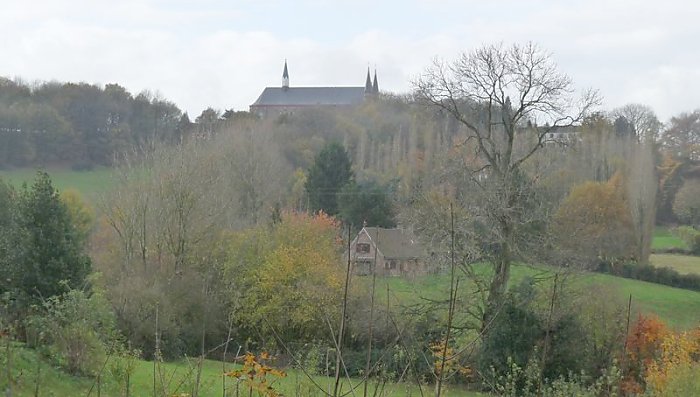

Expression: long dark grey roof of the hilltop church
xmin=251 ymin=87 xmax=365 ymax=107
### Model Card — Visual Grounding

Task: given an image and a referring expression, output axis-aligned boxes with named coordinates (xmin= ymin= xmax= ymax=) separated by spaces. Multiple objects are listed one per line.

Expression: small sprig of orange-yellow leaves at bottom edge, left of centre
xmin=226 ymin=352 xmax=287 ymax=397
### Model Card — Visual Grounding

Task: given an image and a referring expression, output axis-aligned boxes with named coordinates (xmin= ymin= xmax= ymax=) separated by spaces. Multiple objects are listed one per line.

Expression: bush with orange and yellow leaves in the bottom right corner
xmin=621 ymin=315 xmax=700 ymax=396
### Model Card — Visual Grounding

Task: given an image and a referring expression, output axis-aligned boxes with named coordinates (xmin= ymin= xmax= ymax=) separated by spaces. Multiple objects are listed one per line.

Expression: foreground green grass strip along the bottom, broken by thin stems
xmin=0 ymin=344 xmax=482 ymax=397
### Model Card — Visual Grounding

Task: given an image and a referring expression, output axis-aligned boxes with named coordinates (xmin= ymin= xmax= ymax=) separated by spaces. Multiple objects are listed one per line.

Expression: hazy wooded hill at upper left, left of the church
xmin=0 ymin=77 xmax=191 ymax=169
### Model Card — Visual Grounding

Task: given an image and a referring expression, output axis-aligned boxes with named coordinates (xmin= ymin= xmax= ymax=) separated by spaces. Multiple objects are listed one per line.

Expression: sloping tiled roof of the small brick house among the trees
xmin=363 ymin=227 xmax=426 ymax=259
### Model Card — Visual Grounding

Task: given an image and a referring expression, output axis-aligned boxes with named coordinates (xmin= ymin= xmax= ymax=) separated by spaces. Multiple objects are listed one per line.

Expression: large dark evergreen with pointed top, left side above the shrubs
xmin=13 ymin=171 xmax=90 ymax=303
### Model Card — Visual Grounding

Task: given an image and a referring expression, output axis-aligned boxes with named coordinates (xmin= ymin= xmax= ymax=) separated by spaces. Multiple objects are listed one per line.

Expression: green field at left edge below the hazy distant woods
xmin=0 ymin=167 xmax=112 ymax=200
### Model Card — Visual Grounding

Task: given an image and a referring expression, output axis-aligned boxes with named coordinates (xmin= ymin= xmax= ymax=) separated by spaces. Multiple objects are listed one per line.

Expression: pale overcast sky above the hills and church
xmin=0 ymin=0 xmax=700 ymax=121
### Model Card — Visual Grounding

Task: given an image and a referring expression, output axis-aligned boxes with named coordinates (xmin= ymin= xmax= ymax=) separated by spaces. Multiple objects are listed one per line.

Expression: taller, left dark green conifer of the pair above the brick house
xmin=304 ymin=142 xmax=353 ymax=215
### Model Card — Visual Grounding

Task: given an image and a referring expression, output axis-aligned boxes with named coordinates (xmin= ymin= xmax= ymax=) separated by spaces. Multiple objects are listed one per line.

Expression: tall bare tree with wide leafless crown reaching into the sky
xmin=414 ymin=43 xmax=598 ymax=329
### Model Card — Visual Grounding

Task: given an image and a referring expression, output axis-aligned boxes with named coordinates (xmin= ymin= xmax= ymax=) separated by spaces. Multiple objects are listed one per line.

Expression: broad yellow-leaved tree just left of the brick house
xmin=225 ymin=212 xmax=344 ymax=343
